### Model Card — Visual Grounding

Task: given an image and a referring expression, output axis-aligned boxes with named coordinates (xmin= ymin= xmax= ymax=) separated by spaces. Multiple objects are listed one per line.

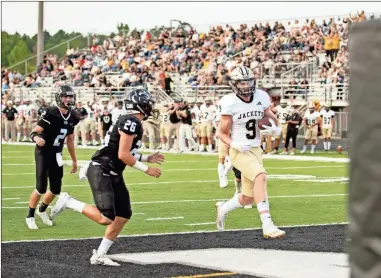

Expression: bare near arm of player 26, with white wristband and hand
xmin=118 ymin=131 xmax=161 ymax=178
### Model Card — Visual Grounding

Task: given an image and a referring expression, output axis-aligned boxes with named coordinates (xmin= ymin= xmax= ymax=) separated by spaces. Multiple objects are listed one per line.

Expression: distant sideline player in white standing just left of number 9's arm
xmin=199 ymin=99 xmax=216 ymax=152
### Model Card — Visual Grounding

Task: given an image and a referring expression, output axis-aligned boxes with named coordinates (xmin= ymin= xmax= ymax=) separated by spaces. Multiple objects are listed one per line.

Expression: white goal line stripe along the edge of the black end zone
xmin=1 ymin=222 xmax=349 ymax=243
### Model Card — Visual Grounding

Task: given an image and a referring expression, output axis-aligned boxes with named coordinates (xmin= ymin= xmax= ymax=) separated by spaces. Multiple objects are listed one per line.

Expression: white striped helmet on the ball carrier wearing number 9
xmin=229 ymin=66 xmax=256 ymax=97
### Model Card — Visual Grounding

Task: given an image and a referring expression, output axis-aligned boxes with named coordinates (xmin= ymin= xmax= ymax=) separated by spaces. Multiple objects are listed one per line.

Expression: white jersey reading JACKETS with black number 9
xmin=220 ymin=89 xmax=270 ymax=147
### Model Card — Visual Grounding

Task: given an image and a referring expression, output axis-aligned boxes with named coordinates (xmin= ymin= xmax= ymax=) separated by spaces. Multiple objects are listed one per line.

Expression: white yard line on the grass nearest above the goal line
xmin=11 ymin=193 xmax=348 ymax=205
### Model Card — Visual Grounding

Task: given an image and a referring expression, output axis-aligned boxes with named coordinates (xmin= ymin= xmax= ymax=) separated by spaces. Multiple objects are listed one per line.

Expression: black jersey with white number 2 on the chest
xmin=36 ymin=106 xmax=79 ymax=153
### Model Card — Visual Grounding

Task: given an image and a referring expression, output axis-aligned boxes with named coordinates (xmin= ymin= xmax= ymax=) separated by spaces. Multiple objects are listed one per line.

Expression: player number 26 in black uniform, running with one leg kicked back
xmin=51 ymin=89 xmax=164 ymax=266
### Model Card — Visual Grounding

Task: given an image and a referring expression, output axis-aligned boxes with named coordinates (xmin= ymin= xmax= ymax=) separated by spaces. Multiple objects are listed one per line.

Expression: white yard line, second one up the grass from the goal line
xmin=0 ymin=175 xmax=344 ymax=189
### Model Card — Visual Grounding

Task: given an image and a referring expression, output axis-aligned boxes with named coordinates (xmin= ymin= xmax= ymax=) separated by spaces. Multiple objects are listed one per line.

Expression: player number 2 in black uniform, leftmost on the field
xmin=26 ymin=85 xmax=79 ymax=230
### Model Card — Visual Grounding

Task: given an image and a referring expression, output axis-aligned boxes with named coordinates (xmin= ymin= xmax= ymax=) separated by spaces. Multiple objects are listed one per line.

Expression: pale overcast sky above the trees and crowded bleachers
xmin=1 ymin=2 xmax=381 ymax=36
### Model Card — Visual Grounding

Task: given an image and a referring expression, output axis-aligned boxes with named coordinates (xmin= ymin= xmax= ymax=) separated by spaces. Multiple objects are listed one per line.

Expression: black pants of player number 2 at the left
xmin=34 ymin=147 xmax=63 ymax=195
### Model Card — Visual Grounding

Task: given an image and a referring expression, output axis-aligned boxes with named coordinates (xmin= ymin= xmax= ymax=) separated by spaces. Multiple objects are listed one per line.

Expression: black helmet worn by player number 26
xmin=124 ymin=89 xmax=155 ymax=120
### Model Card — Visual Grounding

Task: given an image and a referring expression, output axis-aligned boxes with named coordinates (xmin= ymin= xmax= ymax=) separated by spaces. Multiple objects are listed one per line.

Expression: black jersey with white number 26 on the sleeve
xmin=91 ymin=115 xmax=143 ymax=174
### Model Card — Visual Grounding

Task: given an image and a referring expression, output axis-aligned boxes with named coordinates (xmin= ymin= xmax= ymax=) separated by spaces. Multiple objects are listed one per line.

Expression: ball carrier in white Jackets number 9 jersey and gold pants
xmin=216 ymin=66 xmax=285 ymax=238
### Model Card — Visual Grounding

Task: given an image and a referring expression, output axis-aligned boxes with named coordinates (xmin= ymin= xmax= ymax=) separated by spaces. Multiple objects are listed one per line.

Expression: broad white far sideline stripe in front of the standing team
xmin=1 ymin=142 xmax=349 ymax=163
